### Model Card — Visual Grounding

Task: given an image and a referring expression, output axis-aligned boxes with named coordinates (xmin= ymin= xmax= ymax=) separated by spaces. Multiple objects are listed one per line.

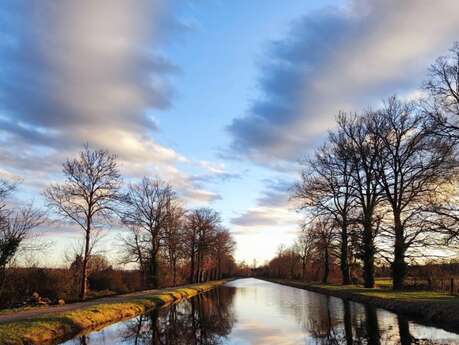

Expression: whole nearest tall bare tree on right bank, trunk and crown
xmin=370 ymin=97 xmax=455 ymax=290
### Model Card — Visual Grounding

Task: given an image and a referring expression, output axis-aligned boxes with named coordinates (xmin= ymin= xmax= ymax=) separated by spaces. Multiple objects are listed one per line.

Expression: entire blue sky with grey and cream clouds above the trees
xmin=0 ymin=0 xmax=459 ymax=265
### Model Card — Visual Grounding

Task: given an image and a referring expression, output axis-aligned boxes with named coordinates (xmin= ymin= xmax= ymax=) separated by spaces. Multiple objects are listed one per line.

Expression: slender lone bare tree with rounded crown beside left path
xmin=44 ymin=145 xmax=121 ymax=300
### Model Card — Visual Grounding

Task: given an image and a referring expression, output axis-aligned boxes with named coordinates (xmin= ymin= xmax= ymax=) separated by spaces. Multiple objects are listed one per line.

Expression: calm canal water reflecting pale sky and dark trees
xmin=61 ymin=279 xmax=459 ymax=345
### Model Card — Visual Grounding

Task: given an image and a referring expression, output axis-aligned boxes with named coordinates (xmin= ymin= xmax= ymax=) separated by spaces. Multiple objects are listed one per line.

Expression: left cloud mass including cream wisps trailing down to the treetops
xmin=0 ymin=0 xmax=218 ymax=201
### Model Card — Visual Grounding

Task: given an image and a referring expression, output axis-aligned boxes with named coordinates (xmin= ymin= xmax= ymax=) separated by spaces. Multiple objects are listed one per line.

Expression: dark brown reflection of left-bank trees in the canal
xmin=123 ymin=287 xmax=235 ymax=345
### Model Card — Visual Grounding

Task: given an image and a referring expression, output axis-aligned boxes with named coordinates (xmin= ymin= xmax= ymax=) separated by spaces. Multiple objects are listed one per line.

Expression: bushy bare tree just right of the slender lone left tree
xmin=122 ymin=177 xmax=175 ymax=288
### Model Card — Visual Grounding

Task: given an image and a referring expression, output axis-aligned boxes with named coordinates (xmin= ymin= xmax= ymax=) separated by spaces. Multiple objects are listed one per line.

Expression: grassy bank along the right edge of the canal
xmin=269 ymin=279 xmax=459 ymax=332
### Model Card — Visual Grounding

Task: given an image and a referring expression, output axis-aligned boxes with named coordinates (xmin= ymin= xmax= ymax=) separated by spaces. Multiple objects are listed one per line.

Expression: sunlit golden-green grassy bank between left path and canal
xmin=0 ymin=280 xmax=225 ymax=345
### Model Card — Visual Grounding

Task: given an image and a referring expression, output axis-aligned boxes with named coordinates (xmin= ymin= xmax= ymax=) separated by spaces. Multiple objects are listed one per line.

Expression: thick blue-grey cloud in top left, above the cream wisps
xmin=0 ymin=0 xmax=176 ymax=140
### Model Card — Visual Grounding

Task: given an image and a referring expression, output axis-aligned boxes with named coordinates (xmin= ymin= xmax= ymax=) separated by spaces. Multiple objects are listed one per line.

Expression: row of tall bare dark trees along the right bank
xmin=268 ymin=44 xmax=459 ymax=290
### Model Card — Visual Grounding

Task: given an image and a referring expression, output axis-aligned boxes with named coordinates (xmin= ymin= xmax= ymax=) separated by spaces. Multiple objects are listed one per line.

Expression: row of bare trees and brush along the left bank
xmin=0 ymin=146 xmax=236 ymax=305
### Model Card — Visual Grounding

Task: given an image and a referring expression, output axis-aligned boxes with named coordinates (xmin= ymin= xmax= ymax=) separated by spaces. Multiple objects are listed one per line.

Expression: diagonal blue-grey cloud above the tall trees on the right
xmin=228 ymin=0 xmax=459 ymax=165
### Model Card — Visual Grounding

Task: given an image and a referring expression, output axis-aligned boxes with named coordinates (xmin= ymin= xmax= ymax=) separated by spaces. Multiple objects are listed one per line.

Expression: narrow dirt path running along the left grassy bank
xmin=0 ymin=286 xmax=167 ymax=323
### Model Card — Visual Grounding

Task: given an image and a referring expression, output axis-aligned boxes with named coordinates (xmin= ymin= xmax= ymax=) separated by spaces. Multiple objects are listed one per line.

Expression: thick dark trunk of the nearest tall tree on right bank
xmin=392 ymin=214 xmax=407 ymax=290
